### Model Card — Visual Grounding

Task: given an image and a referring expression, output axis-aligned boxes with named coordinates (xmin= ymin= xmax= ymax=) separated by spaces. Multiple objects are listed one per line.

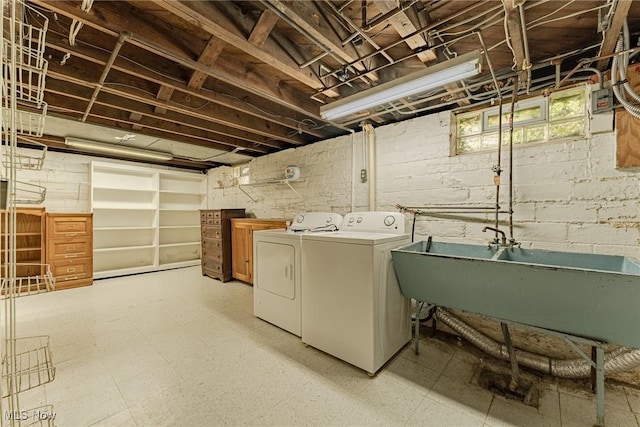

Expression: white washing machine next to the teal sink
xmin=302 ymin=212 xmax=411 ymax=375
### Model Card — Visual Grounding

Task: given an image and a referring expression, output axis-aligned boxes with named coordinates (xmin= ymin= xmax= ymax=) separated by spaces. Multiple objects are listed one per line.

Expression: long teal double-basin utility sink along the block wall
xmin=391 ymin=239 xmax=640 ymax=348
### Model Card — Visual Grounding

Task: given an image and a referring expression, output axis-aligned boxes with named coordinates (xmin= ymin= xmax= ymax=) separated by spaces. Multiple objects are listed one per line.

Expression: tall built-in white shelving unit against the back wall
xmin=91 ymin=162 xmax=206 ymax=278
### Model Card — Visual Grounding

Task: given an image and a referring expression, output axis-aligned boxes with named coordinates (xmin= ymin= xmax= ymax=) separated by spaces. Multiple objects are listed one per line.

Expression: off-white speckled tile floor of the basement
xmin=8 ymin=267 xmax=640 ymax=427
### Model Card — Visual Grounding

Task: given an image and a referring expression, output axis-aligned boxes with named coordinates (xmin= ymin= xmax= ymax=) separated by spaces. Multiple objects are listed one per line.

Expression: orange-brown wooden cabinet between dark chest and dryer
xmin=231 ymin=218 xmax=287 ymax=284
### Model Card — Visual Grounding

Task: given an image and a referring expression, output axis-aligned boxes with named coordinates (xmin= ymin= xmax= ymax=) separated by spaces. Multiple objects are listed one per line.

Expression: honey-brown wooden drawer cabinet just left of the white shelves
xmin=47 ymin=213 xmax=93 ymax=289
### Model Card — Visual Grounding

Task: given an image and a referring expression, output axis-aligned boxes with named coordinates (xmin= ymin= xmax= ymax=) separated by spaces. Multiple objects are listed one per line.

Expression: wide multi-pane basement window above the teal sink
xmin=455 ymin=87 xmax=588 ymax=154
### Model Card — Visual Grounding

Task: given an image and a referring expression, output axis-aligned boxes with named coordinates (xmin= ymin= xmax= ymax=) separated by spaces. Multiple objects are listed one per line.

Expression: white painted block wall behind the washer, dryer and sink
xmin=209 ymin=113 xmax=640 ymax=385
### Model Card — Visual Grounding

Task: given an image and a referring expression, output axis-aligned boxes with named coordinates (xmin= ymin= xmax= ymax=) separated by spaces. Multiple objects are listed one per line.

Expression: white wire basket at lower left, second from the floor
xmin=2 ymin=335 xmax=56 ymax=398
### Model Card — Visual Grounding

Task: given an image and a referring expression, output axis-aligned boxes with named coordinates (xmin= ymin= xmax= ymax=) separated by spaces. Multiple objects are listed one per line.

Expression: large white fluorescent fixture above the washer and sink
xmin=320 ymin=50 xmax=482 ymax=120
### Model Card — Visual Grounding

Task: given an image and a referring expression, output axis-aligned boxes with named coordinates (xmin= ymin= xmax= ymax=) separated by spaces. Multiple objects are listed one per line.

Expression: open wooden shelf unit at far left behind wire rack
xmin=0 ymin=208 xmax=46 ymax=277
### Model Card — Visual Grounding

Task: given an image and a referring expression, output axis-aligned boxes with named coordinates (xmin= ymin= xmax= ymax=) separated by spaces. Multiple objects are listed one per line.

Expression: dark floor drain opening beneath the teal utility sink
xmin=478 ymin=367 xmax=540 ymax=408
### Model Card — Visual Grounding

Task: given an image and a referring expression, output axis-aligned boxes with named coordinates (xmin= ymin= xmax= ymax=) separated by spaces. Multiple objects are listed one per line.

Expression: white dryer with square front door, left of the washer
xmin=253 ymin=212 xmax=342 ymax=336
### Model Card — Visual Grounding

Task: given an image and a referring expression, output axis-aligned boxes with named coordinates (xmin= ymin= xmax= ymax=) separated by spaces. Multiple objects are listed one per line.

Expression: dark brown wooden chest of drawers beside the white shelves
xmin=200 ymin=209 xmax=244 ymax=282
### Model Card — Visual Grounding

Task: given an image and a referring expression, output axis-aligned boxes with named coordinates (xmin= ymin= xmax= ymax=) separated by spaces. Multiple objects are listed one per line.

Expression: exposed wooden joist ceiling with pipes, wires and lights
xmin=15 ymin=0 xmax=640 ymax=169
